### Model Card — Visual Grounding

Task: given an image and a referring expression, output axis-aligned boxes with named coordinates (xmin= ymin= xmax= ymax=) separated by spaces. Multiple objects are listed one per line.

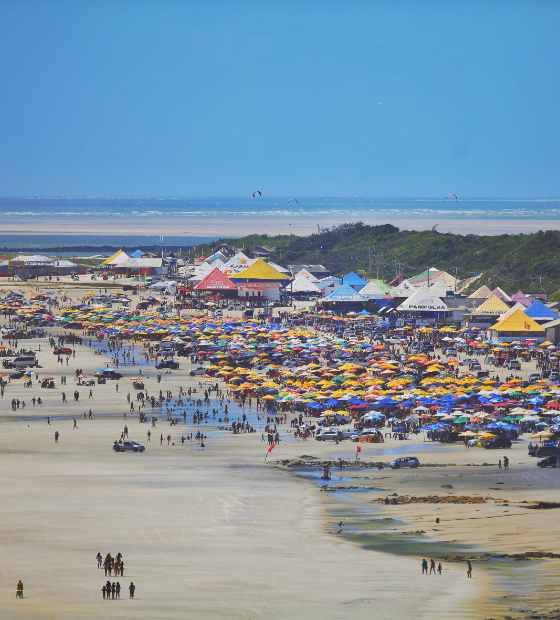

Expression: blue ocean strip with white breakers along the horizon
xmin=0 ymin=195 xmax=560 ymax=222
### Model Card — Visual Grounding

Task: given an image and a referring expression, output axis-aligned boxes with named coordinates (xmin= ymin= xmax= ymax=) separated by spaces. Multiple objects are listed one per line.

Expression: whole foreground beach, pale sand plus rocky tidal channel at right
xmin=0 ymin=287 xmax=560 ymax=620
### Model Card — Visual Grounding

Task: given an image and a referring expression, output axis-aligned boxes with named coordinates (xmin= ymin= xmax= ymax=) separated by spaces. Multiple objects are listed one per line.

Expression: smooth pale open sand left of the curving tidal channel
xmin=0 ymin=314 xmax=486 ymax=619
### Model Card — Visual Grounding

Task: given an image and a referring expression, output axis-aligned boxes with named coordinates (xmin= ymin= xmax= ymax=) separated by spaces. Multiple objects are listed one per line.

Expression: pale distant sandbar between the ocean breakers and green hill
xmin=0 ymin=215 xmax=560 ymax=238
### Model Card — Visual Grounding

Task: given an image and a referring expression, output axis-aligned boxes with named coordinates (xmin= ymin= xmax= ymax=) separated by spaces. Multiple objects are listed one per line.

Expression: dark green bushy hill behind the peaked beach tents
xmin=196 ymin=222 xmax=560 ymax=296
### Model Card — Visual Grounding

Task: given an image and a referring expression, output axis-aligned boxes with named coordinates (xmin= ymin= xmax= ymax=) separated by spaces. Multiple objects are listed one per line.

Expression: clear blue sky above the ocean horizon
xmin=0 ymin=0 xmax=560 ymax=197
